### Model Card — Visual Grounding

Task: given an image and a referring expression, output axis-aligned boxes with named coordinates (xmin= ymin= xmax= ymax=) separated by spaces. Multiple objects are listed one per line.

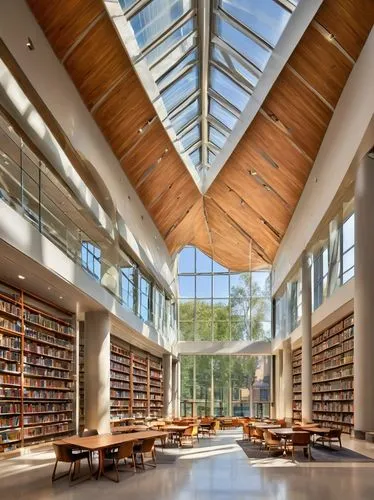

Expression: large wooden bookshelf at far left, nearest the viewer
xmin=0 ymin=283 xmax=75 ymax=452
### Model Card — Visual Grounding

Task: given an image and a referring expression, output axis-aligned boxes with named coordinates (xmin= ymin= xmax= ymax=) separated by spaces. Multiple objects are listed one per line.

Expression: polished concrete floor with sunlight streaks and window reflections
xmin=0 ymin=431 xmax=374 ymax=500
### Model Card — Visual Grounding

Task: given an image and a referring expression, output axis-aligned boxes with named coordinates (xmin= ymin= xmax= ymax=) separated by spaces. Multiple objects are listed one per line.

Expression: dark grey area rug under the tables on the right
xmin=236 ymin=439 xmax=374 ymax=462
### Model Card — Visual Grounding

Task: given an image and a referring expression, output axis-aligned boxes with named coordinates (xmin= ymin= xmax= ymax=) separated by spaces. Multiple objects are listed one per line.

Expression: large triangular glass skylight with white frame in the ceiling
xmin=104 ymin=0 xmax=320 ymax=192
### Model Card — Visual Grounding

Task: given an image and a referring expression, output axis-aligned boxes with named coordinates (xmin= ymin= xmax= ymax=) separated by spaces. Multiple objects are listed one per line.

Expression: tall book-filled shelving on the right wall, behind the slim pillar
xmin=292 ymin=315 xmax=354 ymax=434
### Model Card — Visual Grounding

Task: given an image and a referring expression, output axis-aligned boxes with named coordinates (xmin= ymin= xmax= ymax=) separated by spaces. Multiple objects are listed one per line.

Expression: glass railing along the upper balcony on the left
xmin=0 ymin=127 xmax=177 ymax=340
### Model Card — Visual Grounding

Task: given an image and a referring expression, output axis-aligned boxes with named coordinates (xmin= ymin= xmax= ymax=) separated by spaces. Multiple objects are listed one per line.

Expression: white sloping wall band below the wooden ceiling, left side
xmin=0 ymin=0 xmax=174 ymax=292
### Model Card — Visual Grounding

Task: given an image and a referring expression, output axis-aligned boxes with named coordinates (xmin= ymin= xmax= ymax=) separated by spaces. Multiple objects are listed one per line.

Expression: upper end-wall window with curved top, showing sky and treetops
xmin=178 ymin=247 xmax=271 ymax=340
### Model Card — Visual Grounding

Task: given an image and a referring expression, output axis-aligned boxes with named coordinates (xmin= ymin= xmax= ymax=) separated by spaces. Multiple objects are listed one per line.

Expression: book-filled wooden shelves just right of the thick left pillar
xmin=110 ymin=335 xmax=163 ymax=424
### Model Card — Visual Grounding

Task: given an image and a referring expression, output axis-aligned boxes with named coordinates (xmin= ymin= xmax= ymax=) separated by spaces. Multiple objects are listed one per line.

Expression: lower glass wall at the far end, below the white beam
xmin=181 ymin=355 xmax=271 ymax=417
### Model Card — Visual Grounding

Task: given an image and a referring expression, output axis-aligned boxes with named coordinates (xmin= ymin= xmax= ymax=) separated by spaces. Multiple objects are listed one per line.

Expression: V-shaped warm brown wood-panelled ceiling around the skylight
xmin=28 ymin=0 xmax=374 ymax=271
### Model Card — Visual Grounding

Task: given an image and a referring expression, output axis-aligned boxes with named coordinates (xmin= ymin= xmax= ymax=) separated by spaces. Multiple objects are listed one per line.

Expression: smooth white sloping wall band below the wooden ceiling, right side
xmin=272 ymin=28 xmax=374 ymax=294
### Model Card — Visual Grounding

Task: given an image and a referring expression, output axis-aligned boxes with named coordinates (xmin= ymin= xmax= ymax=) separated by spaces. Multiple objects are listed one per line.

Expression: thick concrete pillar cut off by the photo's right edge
xmin=353 ymin=156 xmax=374 ymax=438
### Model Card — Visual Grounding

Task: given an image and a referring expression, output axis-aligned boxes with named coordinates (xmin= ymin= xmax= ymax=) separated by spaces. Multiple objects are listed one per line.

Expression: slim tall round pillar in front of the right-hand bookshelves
xmin=301 ymin=251 xmax=313 ymax=422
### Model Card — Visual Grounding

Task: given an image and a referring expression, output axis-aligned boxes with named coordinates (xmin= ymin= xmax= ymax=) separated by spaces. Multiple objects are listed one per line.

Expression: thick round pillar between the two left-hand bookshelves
xmin=84 ymin=311 xmax=110 ymax=434
